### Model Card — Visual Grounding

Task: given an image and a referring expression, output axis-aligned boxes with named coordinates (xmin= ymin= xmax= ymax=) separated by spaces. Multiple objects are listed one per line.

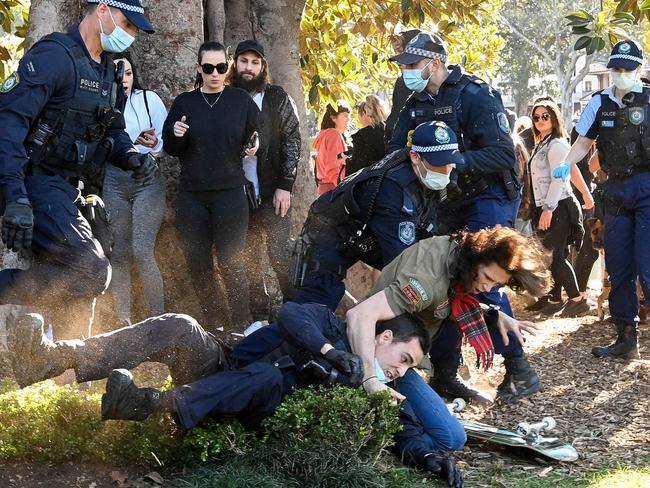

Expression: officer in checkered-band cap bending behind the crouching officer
xmin=387 ymin=32 xmax=541 ymax=402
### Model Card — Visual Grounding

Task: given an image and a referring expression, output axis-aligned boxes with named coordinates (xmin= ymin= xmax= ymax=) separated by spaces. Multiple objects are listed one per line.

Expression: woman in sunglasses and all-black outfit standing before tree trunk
xmin=164 ymin=41 xmax=259 ymax=331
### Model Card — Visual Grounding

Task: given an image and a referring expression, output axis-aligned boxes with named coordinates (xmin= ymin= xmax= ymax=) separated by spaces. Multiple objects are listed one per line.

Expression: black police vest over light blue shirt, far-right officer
xmin=596 ymin=85 xmax=650 ymax=178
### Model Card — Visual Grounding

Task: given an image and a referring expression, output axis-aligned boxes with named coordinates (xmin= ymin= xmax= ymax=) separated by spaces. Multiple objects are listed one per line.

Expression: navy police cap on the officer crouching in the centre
xmin=407 ymin=121 xmax=464 ymax=166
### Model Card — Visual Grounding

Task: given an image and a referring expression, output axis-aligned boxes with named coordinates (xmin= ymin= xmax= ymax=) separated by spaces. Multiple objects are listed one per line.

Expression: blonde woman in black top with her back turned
xmin=345 ymin=95 xmax=387 ymax=175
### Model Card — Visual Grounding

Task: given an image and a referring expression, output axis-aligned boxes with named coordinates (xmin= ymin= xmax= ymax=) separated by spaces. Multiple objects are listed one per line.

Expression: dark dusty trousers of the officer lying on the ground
xmin=54 ymin=314 xmax=284 ymax=429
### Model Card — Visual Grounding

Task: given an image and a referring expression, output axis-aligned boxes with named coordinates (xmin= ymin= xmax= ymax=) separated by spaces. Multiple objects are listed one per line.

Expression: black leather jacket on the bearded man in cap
xmin=257 ymin=85 xmax=300 ymax=199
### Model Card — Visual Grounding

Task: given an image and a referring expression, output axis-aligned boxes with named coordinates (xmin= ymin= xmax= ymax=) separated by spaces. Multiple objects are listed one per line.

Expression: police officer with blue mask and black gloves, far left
xmin=0 ymin=0 xmax=157 ymax=338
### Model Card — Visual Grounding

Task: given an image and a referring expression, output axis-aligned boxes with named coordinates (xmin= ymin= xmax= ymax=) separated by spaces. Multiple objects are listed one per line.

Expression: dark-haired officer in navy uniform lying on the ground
xmin=5 ymin=303 xmax=465 ymax=487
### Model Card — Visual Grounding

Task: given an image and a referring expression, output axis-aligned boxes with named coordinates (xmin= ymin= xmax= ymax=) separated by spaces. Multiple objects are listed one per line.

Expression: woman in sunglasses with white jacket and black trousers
xmin=528 ymin=100 xmax=589 ymax=317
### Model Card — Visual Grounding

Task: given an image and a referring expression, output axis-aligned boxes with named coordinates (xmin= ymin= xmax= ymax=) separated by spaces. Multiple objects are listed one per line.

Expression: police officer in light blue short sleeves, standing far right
xmin=553 ymin=40 xmax=650 ymax=359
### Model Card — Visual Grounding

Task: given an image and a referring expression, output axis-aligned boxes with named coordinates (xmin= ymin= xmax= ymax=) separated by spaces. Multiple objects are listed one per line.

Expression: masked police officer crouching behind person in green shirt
xmin=291 ymin=122 xmax=460 ymax=310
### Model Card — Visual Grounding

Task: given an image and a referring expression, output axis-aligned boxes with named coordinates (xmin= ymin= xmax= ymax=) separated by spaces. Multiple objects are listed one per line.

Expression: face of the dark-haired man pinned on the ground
xmin=375 ymin=330 xmax=424 ymax=380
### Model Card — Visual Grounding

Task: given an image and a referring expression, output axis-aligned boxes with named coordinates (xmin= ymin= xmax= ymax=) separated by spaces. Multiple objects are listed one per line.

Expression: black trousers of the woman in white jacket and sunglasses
xmin=533 ymin=197 xmax=580 ymax=299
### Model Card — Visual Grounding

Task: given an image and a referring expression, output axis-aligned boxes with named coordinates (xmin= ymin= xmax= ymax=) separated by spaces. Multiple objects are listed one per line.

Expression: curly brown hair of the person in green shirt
xmin=451 ymin=225 xmax=551 ymax=297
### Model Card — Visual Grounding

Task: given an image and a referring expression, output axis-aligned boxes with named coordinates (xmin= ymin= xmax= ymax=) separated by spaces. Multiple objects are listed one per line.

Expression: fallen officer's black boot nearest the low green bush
xmin=102 ymin=369 xmax=166 ymax=420
